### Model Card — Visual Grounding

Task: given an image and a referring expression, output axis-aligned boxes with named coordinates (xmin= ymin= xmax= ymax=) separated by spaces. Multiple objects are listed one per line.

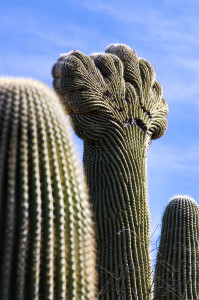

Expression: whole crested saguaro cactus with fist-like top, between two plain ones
xmin=52 ymin=44 xmax=168 ymax=300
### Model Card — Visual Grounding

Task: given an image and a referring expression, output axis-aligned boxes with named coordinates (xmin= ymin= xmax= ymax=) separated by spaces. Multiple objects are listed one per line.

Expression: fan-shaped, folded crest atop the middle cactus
xmin=52 ymin=44 xmax=168 ymax=141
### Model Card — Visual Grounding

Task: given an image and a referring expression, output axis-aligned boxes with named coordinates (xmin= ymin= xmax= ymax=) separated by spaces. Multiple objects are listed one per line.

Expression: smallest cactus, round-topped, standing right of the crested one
xmin=154 ymin=196 xmax=199 ymax=300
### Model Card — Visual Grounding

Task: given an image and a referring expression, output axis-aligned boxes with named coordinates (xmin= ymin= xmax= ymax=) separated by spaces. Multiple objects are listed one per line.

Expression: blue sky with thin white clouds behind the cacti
xmin=0 ymin=0 xmax=199 ymax=266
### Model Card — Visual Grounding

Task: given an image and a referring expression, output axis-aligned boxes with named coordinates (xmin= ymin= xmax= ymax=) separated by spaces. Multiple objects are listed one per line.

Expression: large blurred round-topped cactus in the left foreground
xmin=0 ymin=78 xmax=96 ymax=300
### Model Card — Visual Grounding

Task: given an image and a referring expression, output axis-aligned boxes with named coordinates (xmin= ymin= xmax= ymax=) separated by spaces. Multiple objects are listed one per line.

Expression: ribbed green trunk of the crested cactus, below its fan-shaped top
xmin=84 ymin=128 xmax=151 ymax=299
